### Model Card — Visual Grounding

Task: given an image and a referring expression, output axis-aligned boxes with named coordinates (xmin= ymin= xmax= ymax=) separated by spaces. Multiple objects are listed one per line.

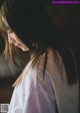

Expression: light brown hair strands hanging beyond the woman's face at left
xmin=0 ymin=7 xmax=29 ymax=70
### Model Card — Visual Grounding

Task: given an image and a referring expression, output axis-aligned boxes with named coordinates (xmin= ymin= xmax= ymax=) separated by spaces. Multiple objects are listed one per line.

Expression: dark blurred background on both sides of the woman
xmin=0 ymin=0 xmax=80 ymax=103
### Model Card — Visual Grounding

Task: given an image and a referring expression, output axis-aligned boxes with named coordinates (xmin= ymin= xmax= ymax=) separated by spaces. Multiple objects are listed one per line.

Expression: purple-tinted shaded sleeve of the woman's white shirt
xmin=24 ymin=68 xmax=57 ymax=113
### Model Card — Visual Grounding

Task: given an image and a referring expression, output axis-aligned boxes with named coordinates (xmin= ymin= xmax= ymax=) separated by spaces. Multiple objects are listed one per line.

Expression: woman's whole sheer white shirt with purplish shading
xmin=8 ymin=51 xmax=79 ymax=113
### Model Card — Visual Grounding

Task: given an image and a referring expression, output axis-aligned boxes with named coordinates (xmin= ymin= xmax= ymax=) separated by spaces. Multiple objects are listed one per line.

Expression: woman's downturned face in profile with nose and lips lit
xmin=2 ymin=18 xmax=29 ymax=51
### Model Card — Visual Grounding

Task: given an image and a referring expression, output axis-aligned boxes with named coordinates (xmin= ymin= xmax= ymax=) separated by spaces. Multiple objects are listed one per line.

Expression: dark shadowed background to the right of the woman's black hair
xmin=46 ymin=3 xmax=80 ymax=62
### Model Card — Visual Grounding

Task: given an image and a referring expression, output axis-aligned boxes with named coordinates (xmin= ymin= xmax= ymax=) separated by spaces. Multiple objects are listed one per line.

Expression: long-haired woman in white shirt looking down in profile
xmin=0 ymin=0 xmax=79 ymax=113
